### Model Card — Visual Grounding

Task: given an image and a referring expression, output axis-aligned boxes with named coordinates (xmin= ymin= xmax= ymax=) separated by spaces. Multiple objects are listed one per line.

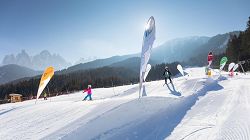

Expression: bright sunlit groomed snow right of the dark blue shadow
xmin=167 ymin=74 xmax=250 ymax=140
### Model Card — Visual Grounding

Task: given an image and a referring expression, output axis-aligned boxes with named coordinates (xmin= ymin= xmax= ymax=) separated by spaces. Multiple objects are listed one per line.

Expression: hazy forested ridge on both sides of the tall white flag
xmin=58 ymin=31 xmax=239 ymax=74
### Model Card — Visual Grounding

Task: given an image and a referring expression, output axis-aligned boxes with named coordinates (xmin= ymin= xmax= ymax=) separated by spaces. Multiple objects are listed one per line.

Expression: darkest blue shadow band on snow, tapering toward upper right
xmin=104 ymin=78 xmax=225 ymax=140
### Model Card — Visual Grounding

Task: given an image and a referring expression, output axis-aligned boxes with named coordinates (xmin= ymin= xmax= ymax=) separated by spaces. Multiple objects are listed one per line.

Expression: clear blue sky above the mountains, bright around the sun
xmin=0 ymin=0 xmax=250 ymax=62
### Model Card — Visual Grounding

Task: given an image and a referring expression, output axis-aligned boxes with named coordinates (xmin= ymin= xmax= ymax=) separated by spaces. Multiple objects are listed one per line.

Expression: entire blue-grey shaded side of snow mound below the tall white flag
xmin=46 ymin=77 xmax=225 ymax=140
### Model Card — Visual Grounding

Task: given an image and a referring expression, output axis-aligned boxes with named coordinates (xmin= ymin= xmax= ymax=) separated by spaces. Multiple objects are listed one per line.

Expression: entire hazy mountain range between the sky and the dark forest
xmin=0 ymin=31 xmax=239 ymax=84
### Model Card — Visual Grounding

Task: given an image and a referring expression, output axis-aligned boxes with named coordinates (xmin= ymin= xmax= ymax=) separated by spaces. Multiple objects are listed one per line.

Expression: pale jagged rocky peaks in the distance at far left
xmin=2 ymin=50 xmax=71 ymax=70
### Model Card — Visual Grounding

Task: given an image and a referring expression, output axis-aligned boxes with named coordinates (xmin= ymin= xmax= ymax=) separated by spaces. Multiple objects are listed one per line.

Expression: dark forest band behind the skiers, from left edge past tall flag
xmin=0 ymin=62 xmax=178 ymax=100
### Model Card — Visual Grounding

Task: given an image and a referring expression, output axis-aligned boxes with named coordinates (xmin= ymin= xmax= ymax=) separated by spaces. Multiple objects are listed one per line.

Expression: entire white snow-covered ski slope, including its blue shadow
xmin=0 ymin=68 xmax=250 ymax=140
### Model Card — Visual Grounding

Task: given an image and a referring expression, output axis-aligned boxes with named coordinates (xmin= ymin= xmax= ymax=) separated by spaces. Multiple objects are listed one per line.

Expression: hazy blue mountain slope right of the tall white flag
xmin=151 ymin=31 xmax=240 ymax=65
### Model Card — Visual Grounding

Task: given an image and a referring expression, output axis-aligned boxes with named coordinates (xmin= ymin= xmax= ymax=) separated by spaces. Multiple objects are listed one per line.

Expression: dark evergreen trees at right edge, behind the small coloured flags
xmin=183 ymin=17 xmax=250 ymax=71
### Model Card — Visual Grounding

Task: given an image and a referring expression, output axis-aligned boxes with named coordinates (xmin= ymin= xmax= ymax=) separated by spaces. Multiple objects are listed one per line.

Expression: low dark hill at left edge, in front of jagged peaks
xmin=0 ymin=64 xmax=42 ymax=84
